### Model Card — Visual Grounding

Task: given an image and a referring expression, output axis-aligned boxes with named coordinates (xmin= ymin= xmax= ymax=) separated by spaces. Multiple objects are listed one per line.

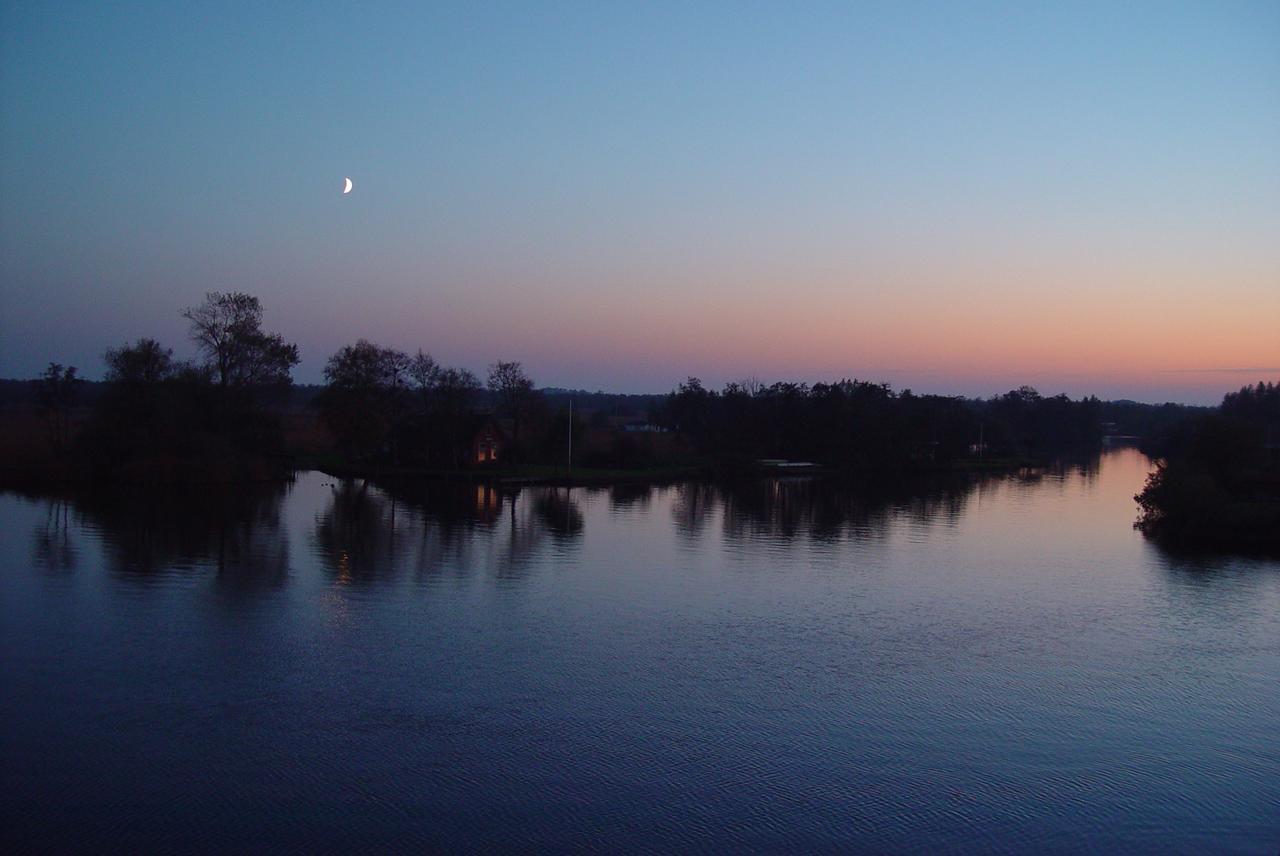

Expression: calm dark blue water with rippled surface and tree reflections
xmin=0 ymin=450 xmax=1280 ymax=855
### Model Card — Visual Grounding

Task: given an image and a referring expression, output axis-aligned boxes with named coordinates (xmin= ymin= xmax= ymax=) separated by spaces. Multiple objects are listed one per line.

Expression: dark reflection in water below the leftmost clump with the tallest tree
xmin=35 ymin=481 xmax=291 ymax=590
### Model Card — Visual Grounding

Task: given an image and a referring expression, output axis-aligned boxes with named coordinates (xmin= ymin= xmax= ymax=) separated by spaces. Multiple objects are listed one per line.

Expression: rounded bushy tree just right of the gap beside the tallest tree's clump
xmin=316 ymin=339 xmax=411 ymax=457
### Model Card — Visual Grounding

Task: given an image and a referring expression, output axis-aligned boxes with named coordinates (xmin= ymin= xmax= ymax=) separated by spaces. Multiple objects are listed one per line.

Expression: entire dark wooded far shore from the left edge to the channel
xmin=0 ymin=292 xmax=1269 ymax=486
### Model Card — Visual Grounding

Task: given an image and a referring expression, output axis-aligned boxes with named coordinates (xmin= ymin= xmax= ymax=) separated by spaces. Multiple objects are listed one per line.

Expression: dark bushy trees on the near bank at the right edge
xmin=1137 ymin=381 xmax=1280 ymax=549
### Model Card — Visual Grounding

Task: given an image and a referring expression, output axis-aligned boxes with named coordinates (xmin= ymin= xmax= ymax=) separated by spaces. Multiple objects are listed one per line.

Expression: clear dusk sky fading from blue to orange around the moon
xmin=0 ymin=0 xmax=1280 ymax=403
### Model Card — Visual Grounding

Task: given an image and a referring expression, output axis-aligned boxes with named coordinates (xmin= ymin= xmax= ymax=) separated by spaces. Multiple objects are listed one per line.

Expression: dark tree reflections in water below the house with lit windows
xmin=315 ymin=480 xmax=582 ymax=582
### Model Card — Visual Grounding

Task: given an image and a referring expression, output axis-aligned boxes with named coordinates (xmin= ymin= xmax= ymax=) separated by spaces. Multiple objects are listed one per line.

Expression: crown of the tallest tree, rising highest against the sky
xmin=182 ymin=292 xmax=298 ymax=389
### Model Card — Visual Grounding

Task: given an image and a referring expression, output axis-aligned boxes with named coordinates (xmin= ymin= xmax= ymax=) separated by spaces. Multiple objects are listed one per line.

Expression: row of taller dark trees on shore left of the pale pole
xmin=16 ymin=292 xmax=586 ymax=481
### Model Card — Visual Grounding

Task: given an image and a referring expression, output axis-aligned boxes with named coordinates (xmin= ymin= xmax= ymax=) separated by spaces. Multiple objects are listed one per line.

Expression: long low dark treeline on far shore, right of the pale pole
xmin=659 ymin=377 xmax=1102 ymax=470
